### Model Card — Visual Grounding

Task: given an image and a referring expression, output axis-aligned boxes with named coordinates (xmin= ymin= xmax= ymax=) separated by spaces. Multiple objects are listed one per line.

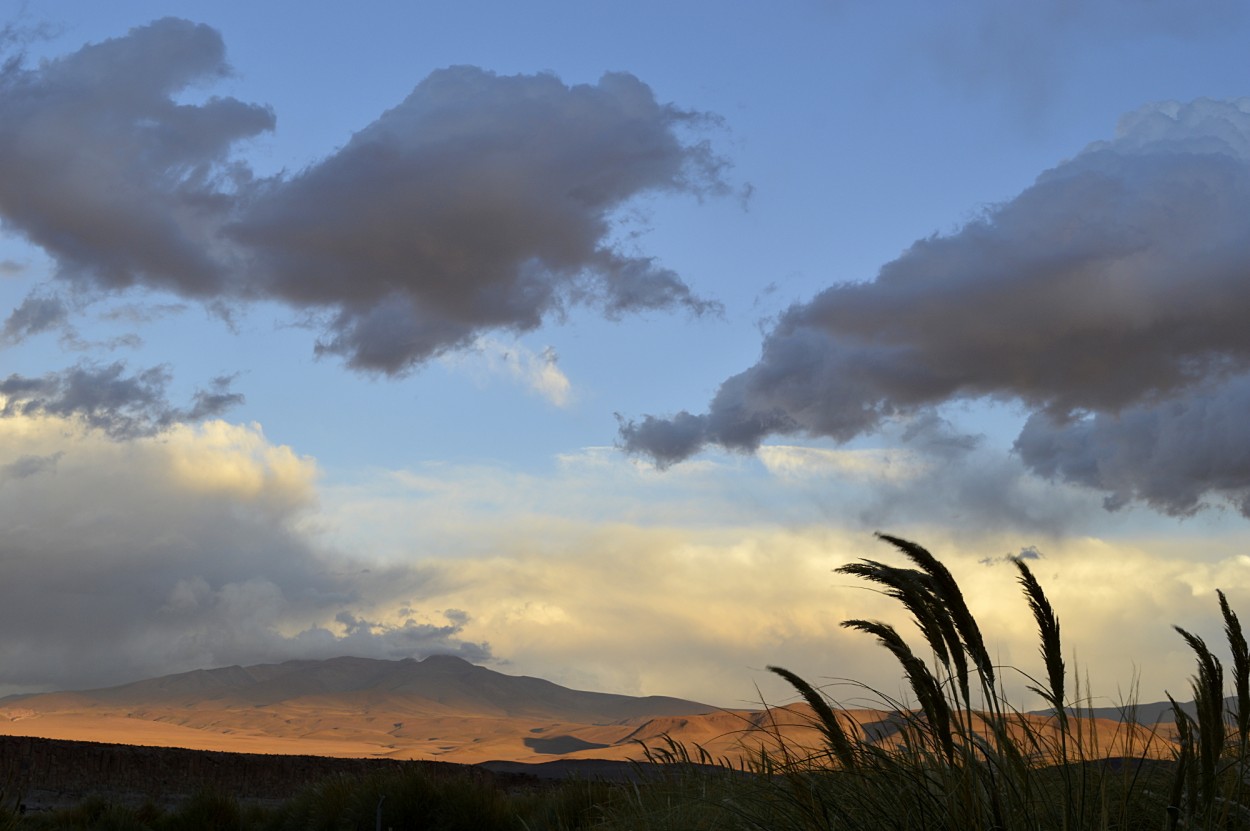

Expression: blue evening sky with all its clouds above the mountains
xmin=0 ymin=0 xmax=1250 ymax=706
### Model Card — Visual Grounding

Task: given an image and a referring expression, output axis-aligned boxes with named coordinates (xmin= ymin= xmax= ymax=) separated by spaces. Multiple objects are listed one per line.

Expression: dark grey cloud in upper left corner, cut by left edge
xmin=0 ymin=19 xmax=274 ymax=296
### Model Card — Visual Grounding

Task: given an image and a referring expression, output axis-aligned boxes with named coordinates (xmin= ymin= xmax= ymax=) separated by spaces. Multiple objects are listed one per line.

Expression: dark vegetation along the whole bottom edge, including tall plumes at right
xmin=7 ymin=527 xmax=1250 ymax=831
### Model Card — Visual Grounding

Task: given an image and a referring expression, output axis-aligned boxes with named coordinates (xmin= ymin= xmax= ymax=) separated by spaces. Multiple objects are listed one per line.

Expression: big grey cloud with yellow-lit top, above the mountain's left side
xmin=0 ymin=415 xmax=490 ymax=691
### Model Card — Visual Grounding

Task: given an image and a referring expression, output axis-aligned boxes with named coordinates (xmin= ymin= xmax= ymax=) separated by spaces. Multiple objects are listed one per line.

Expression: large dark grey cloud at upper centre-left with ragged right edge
xmin=231 ymin=66 xmax=724 ymax=372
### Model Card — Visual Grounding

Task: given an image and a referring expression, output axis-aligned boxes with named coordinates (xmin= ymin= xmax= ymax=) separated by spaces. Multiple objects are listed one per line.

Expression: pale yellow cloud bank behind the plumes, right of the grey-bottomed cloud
xmin=315 ymin=446 xmax=1248 ymax=706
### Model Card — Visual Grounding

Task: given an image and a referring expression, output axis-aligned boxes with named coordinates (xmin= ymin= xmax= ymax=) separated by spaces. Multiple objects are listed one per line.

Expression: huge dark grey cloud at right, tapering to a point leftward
xmin=621 ymin=99 xmax=1250 ymax=512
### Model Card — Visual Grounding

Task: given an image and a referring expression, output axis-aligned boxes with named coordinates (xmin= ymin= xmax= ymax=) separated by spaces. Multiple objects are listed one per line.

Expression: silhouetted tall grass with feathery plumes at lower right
xmin=613 ymin=535 xmax=1250 ymax=831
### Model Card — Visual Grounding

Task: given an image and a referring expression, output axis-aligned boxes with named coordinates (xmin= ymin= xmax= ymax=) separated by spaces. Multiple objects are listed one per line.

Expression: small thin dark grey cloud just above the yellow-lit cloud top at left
xmin=0 ymin=361 xmax=243 ymax=439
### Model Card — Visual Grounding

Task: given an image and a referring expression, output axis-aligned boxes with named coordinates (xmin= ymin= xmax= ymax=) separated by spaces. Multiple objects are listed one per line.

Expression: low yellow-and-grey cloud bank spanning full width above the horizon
xmin=0 ymin=416 xmax=1246 ymax=706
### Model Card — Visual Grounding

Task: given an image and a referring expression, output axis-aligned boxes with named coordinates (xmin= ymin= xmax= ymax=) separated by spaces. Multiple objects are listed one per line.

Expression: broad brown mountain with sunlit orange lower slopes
xmin=0 ymin=655 xmax=750 ymax=762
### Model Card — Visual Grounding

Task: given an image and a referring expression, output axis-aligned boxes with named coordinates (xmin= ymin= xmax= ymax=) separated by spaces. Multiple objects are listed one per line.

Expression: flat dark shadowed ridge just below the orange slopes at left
xmin=0 ymin=736 xmax=634 ymax=811
